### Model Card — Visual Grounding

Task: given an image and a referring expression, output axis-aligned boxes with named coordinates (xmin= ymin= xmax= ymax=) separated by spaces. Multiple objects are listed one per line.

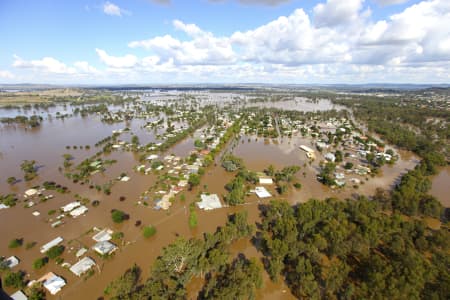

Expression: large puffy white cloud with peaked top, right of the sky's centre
xmin=231 ymin=9 xmax=351 ymax=66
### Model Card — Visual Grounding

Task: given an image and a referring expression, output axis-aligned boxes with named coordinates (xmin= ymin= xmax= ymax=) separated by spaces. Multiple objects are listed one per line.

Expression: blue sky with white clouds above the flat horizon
xmin=0 ymin=0 xmax=450 ymax=84
